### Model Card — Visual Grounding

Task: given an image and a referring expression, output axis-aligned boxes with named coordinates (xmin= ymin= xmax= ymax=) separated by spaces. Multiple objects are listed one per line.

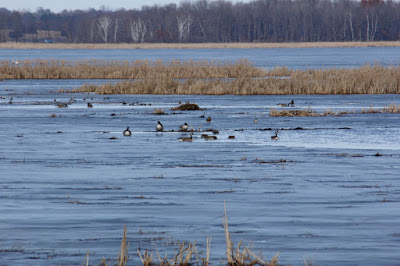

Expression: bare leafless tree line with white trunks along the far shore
xmin=0 ymin=0 xmax=400 ymax=43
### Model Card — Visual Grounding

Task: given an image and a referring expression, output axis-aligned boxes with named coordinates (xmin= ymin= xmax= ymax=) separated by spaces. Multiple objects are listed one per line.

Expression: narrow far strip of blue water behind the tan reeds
xmin=0 ymin=47 xmax=400 ymax=69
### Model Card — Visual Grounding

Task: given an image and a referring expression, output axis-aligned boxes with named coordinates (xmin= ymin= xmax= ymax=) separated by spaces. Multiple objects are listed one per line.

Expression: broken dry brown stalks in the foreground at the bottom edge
xmin=82 ymin=202 xmax=279 ymax=266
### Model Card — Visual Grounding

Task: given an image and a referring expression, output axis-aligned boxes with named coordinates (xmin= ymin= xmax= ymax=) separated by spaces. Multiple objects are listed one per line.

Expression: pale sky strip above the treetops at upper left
xmin=0 ymin=0 xmax=250 ymax=12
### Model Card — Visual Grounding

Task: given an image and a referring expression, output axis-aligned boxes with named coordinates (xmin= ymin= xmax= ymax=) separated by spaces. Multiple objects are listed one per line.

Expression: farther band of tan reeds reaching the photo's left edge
xmin=0 ymin=59 xmax=265 ymax=80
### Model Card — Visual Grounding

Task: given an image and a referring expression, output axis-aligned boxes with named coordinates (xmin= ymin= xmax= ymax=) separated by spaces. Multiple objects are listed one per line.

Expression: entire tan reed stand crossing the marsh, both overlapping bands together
xmin=0 ymin=59 xmax=400 ymax=95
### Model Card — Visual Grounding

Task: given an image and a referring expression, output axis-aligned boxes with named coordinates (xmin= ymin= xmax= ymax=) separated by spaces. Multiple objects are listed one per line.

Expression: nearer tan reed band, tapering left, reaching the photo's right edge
xmin=74 ymin=65 xmax=400 ymax=95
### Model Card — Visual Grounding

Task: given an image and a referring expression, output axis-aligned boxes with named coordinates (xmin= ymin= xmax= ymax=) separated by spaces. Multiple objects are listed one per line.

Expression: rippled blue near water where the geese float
xmin=0 ymin=78 xmax=400 ymax=265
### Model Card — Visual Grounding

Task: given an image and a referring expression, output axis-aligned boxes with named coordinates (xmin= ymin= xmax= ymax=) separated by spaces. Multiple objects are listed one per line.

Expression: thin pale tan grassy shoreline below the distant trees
xmin=0 ymin=41 xmax=400 ymax=49
